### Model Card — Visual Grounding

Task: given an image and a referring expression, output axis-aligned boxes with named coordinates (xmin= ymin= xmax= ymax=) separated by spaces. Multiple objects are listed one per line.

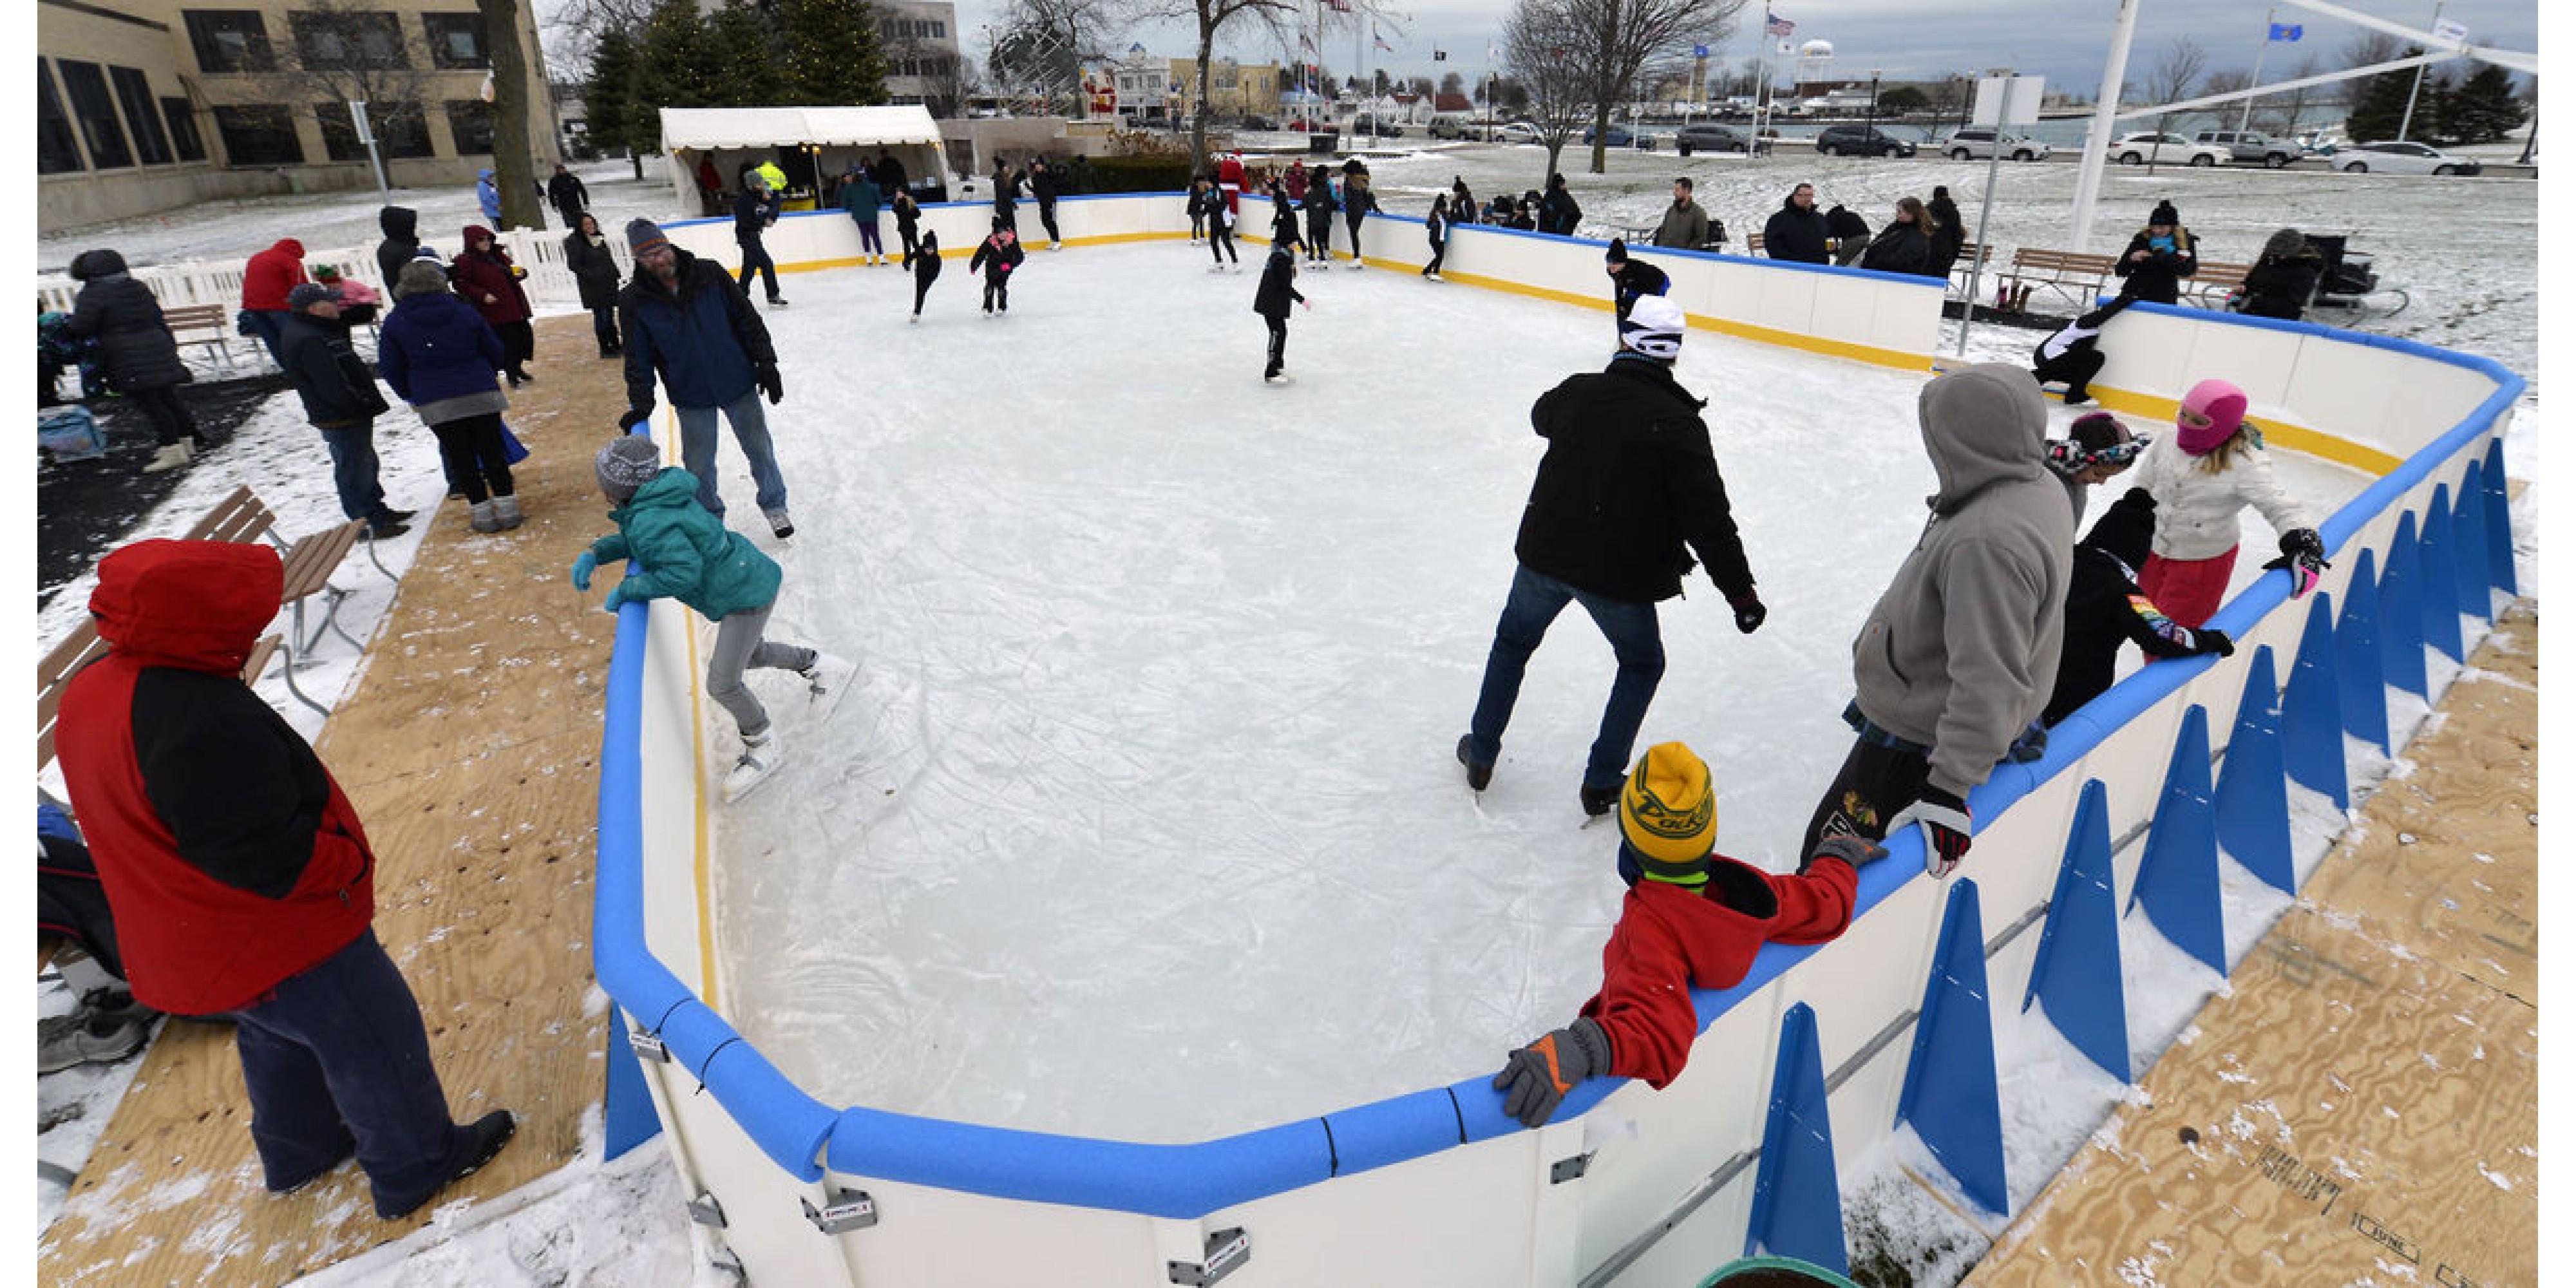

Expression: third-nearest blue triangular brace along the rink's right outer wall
xmin=2022 ymin=773 xmax=2123 ymax=1082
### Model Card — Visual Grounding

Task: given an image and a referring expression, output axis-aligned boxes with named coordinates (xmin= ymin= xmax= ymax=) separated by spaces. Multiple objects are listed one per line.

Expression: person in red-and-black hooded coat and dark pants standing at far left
xmin=54 ymin=541 xmax=515 ymax=1221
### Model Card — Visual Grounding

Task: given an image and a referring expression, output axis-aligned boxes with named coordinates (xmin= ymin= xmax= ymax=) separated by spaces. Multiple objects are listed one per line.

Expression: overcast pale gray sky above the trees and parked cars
xmin=958 ymin=0 xmax=2540 ymax=98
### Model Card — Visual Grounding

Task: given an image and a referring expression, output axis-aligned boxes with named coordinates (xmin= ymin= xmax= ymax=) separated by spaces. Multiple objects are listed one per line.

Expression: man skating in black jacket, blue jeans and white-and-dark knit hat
xmin=1458 ymin=296 xmax=1765 ymax=814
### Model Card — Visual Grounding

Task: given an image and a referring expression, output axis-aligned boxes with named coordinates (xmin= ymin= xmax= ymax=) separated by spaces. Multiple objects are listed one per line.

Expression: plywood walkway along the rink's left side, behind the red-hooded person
xmin=39 ymin=314 xmax=626 ymax=1285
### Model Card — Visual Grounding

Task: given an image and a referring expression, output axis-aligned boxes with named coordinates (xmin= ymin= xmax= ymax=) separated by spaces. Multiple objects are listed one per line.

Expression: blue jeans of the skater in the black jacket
xmin=1466 ymin=567 xmax=1664 ymax=791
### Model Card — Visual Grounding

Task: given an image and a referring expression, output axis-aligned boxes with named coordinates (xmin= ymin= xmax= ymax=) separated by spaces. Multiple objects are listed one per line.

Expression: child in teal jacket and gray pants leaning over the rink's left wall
xmin=572 ymin=435 xmax=855 ymax=801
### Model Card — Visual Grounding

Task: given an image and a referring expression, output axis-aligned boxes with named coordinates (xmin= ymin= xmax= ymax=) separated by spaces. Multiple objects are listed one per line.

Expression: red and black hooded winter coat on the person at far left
xmin=54 ymin=541 xmax=376 ymax=1015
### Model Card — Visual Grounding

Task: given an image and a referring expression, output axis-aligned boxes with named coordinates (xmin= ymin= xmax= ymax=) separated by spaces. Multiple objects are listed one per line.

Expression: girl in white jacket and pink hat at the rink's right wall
xmin=2130 ymin=379 xmax=2326 ymax=626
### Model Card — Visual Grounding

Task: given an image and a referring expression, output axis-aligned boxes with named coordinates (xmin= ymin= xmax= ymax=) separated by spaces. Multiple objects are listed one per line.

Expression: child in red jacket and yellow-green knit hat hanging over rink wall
xmin=1494 ymin=742 xmax=1886 ymax=1128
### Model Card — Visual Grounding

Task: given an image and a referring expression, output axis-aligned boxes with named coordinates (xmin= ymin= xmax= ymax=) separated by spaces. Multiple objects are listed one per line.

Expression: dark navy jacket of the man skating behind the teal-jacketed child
xmin=618 ymin=250 xmax=778 ymax=412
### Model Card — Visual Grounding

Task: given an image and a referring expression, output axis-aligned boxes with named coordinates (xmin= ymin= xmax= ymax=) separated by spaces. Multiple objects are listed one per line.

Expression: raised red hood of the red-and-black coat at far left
xmin=90 ymin=541 xmax=286 ymax=675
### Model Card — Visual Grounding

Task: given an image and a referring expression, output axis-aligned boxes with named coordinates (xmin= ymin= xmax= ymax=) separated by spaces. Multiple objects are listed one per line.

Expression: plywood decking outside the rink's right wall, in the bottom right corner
xmin=1968 ymin=603 xmax=2540 ymax=1288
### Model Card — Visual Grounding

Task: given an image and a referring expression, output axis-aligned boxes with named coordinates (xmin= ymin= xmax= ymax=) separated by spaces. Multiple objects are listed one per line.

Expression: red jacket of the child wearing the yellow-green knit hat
xmin=1582 ymin=855 xmax=1860 ymax=1090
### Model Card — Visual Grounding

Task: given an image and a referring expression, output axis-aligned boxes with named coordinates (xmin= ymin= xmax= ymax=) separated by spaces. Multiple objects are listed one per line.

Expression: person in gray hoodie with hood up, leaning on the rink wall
xmin=1798 ymin=363 xmax=2074 ymax=876
